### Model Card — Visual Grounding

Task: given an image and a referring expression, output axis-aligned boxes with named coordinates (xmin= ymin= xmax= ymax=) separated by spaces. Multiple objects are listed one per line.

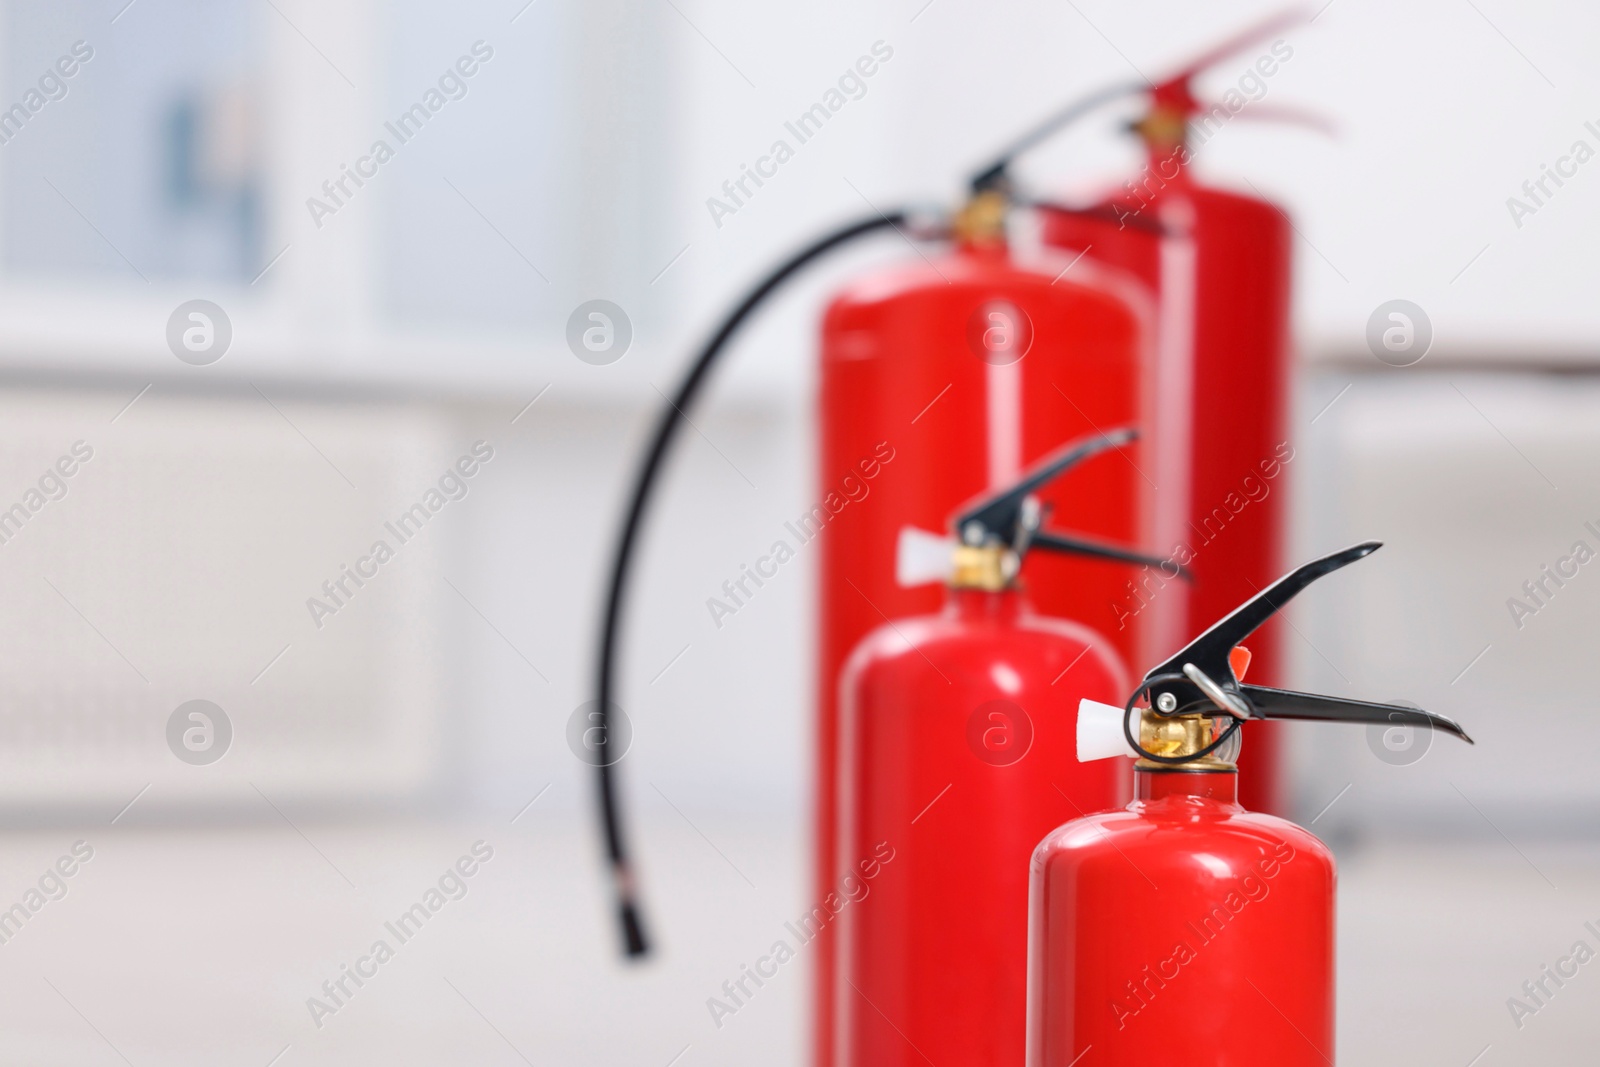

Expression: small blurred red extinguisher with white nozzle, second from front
xmin=829 ymin=430 xmax=1177 ymax=1067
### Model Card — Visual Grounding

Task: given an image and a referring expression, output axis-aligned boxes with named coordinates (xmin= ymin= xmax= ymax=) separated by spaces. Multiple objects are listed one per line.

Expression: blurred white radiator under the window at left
xmin=0 ymin=386 xmax=464 ymax=819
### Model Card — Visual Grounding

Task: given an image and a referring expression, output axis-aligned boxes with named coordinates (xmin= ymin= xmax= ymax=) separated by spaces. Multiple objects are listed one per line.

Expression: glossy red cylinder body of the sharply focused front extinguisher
xmin=1027 ymin=771 xmax=1334 ymax=1067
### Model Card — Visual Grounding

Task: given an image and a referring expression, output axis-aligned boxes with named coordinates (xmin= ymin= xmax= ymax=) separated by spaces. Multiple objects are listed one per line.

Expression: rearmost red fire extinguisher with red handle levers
xmin=1045 ymin=10 xmax=1309 ymax=811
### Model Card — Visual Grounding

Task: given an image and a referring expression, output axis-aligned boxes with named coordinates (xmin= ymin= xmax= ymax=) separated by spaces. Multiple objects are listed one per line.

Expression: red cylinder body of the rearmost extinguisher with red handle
xmin=1045 ymin=168 xmax=1294 ymax=811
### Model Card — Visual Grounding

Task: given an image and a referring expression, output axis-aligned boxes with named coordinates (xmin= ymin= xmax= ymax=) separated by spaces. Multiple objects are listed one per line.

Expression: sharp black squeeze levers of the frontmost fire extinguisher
xmin=1141 ymin=541 xmax=1474 ymax=744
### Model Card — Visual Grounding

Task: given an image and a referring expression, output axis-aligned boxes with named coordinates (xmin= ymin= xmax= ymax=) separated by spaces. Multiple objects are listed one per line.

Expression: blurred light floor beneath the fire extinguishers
xmin=0 ymin=808 xmax=1600 ymax=1067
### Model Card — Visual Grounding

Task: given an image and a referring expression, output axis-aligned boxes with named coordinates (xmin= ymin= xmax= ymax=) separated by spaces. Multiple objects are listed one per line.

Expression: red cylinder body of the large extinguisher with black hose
xmin=813 ymin=241 xmax=1154 ymax=1067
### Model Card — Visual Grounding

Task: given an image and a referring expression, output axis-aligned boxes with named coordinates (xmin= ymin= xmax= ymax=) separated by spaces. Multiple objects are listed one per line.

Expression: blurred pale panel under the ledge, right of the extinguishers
xmin=1285 ymin=368 xmax=1600 ymax=840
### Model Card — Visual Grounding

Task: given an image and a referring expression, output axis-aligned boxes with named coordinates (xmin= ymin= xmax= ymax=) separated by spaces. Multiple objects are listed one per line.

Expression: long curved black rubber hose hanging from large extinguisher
xmin=595 ymin=211 xmax=907 ymax=957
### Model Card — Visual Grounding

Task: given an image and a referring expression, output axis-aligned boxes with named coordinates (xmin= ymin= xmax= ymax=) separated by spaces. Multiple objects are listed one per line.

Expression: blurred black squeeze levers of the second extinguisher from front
xmin=954 ymin=429 xmax=1189 ymax=581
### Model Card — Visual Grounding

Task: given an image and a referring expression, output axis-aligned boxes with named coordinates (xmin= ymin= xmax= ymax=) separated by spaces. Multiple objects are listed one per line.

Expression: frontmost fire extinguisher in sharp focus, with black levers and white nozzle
xmin=1027 ymin=541 xmax=1472 ymax=1067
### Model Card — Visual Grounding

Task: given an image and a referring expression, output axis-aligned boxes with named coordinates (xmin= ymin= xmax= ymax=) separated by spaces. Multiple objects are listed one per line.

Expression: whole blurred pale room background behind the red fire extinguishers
xmin=0 ymin=0 xmax=1600 ymax=1067
